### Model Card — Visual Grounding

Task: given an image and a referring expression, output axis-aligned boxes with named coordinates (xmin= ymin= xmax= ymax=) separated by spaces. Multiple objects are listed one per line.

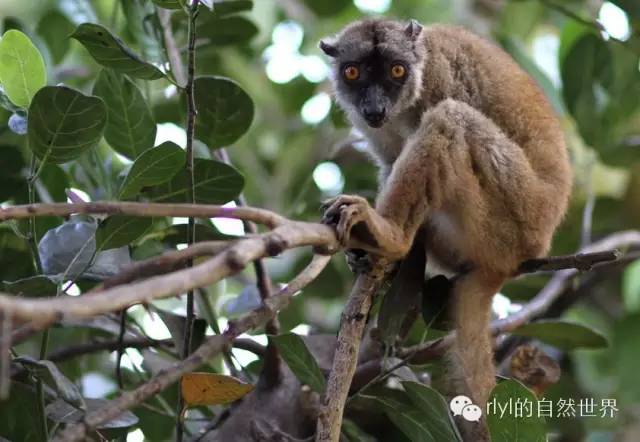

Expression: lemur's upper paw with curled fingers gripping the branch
xmin=322 ymin=195 xmax=373 ymax=247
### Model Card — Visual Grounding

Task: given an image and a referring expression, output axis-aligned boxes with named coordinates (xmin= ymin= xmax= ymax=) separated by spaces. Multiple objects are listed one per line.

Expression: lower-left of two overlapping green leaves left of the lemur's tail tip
xmin=358 ymin=388 xmax=440 ymax=442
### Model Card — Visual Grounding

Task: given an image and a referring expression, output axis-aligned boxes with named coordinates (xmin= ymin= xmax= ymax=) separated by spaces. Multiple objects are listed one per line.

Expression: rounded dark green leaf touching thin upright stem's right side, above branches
xmin=195 ymin=77 xmax=254 ymax=149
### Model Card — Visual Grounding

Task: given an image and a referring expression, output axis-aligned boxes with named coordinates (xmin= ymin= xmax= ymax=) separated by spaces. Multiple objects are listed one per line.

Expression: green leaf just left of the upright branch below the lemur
xmin=270 ymin=333 xmax=326 ymax=394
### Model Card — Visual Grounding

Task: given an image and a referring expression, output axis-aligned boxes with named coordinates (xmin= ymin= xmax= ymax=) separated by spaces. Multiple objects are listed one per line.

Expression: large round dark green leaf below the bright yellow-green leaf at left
xmin=27 ymin=86 xmax=107 ymax=163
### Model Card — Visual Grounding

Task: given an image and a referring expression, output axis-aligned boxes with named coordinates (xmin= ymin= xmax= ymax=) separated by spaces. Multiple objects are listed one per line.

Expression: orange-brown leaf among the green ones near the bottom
xmin=180 ymin=373 xmax=253 ymax=407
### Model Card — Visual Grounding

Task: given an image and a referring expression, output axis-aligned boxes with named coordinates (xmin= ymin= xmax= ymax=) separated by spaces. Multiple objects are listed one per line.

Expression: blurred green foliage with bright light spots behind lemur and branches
xmin=0 ymin=0 xmax=640 ymax=441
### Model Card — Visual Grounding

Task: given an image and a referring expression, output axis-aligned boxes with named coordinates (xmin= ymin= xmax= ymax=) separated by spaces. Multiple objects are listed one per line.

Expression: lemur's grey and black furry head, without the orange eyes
xmin=320 ymin=19 xmax=426 ymax=128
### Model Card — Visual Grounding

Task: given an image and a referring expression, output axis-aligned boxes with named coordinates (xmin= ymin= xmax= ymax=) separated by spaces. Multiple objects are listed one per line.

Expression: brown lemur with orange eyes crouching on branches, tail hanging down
xmin=320 ymin=19 xmax=572 ymax=428
